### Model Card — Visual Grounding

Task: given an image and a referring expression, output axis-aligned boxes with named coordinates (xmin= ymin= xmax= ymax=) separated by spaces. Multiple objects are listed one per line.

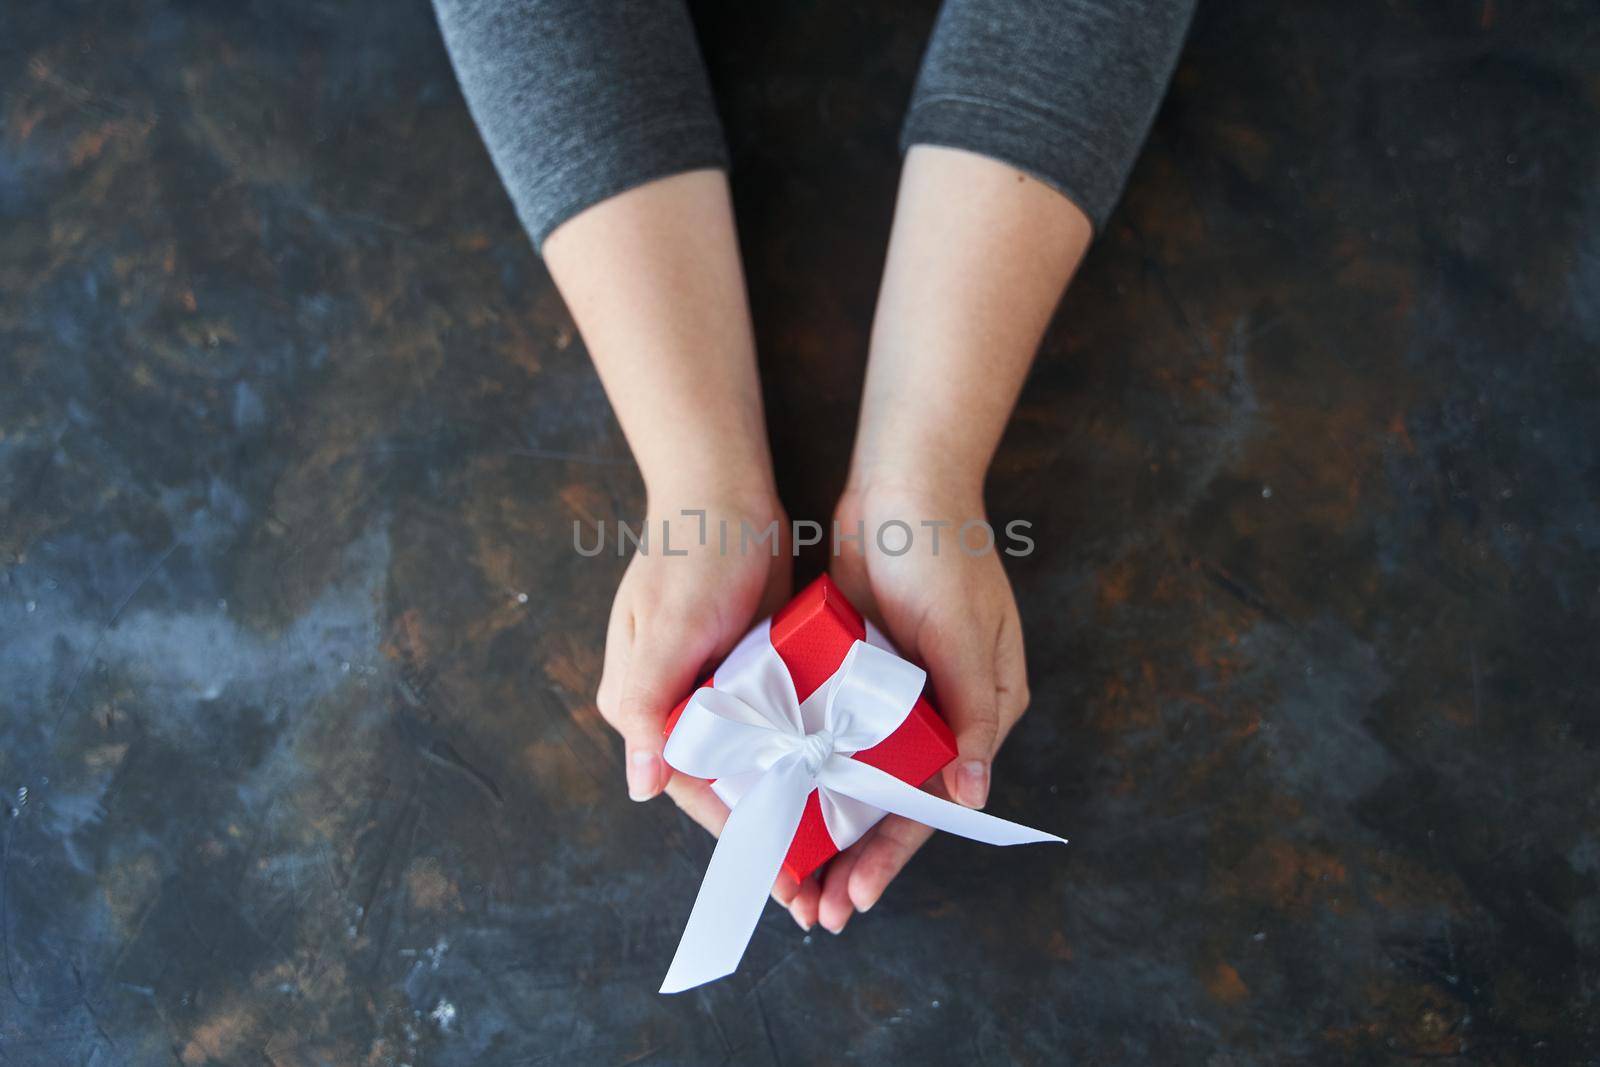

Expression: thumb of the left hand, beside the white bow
xmin=613 ymin=617 xmax=714 ymax=800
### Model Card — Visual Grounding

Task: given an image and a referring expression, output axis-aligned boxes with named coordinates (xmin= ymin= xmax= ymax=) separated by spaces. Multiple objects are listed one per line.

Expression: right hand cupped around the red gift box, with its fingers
xmin=776 ymin=485 xmax=1029 ymax=934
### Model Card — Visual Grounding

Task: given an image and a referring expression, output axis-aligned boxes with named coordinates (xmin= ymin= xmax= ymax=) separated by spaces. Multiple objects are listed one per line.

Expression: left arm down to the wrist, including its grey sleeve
xmin=435 ymin=0 xmax=771 ymax=504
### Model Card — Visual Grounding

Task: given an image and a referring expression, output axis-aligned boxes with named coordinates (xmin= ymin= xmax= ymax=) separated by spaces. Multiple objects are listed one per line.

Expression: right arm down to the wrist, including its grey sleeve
xmin=853 ymin=0 xmax=1194 ymax=501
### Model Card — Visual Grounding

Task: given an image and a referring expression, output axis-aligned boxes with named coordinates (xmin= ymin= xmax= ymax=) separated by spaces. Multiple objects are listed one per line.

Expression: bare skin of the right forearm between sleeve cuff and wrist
xmin=851 ymin=146 xmax=1091 ymax=498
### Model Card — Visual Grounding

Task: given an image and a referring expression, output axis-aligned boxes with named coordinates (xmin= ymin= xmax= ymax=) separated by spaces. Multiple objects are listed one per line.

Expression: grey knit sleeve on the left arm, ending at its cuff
xmin=434 ymin=0 xmax=728 ymax=248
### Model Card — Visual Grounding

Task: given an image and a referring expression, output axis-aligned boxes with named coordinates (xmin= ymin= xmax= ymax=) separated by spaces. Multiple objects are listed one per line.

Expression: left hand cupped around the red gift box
xmin=595 ymin=478 xmax=794 ymax=833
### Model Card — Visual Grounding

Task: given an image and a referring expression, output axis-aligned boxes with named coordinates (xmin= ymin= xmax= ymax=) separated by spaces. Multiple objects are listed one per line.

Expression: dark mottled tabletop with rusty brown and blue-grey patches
xmin=0 ymin=0 xmax=1600 ymax=1067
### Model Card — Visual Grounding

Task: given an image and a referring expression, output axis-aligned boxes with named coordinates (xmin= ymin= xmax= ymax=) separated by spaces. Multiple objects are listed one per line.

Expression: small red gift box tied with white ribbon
xmin=666 ymin=574 xmax=955 ymax=881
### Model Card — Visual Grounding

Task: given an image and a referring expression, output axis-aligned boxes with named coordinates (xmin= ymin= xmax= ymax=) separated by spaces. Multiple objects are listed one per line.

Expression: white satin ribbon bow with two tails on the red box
xmin=661 ymin=622 xmax=1066 ymax=993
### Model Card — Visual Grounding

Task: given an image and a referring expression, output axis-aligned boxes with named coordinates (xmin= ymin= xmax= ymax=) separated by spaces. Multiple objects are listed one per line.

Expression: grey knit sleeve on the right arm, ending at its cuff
xmin=901 ymin=0 xmax=1195 ymax=230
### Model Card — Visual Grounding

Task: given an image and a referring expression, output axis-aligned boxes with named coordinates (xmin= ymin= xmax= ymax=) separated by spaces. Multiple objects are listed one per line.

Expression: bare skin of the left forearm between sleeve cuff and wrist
xmin=544 ymin=170 xmax=774 ymax=506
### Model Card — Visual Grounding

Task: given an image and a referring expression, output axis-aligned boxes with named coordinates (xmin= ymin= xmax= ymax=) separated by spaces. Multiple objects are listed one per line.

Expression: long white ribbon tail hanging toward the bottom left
xmin=661 ymin=755 xmax=813 ymax=993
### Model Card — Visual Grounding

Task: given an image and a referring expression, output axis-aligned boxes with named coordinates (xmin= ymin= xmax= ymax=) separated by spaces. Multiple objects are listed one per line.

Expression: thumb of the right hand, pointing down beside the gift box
xmin=918 ymin=607 xmax=1000 ymax=808
